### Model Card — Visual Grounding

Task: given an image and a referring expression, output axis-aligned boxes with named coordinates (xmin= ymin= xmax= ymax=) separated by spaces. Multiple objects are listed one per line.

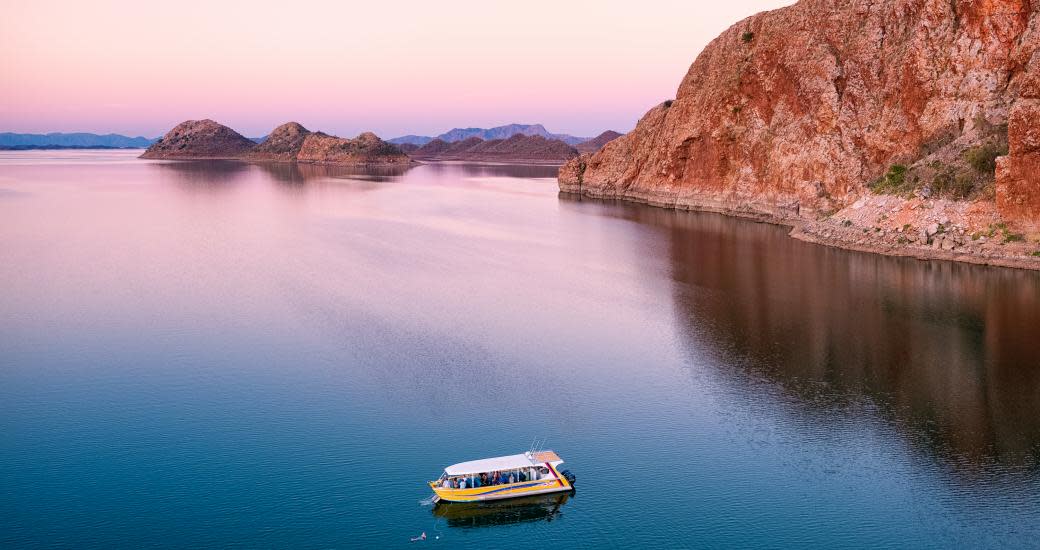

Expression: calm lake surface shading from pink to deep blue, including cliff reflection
xmin=0 ymin=152 xmax=1040 ymax=549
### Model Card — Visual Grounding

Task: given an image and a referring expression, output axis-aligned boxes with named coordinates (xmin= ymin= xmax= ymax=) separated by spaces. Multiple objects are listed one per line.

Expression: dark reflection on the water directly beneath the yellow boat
xmin=433 ymin=493 xmax=573 ymax=528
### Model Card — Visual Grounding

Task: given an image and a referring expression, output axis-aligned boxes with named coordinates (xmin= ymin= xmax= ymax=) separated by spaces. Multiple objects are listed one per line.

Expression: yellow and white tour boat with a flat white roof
xmin=430 ymin=450 xmax=574 ymax=502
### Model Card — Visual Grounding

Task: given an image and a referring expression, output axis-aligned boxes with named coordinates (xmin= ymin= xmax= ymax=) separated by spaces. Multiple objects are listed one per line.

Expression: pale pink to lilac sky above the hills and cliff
xmin=0 ymin=0 xmax=791 ymax=137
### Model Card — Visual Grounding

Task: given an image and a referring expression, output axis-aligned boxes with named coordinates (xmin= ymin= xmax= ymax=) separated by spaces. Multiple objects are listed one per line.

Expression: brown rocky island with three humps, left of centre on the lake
xmin=140 ymin=120 xmax=412 ymax=166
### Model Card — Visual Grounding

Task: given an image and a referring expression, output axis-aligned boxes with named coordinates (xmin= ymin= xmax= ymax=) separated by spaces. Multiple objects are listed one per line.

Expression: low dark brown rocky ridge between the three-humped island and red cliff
xmin=411 ymin=134 xmax=578 ymax=164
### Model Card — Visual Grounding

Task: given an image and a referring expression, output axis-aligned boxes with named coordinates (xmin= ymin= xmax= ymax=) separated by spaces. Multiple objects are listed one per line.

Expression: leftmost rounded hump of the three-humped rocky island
xmin=140 ymin=119 xmax=256 ymax=159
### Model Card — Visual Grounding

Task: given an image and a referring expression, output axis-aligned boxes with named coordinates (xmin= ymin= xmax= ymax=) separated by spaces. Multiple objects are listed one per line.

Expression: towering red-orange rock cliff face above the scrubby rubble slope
xmin=560 ymin=0 xmax=1040 ymax=224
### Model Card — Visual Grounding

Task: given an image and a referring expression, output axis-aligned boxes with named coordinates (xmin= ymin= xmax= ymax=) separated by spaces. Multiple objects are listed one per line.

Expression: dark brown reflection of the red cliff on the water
xmin=561 ymin=195 xmax=1040 ymax=473
